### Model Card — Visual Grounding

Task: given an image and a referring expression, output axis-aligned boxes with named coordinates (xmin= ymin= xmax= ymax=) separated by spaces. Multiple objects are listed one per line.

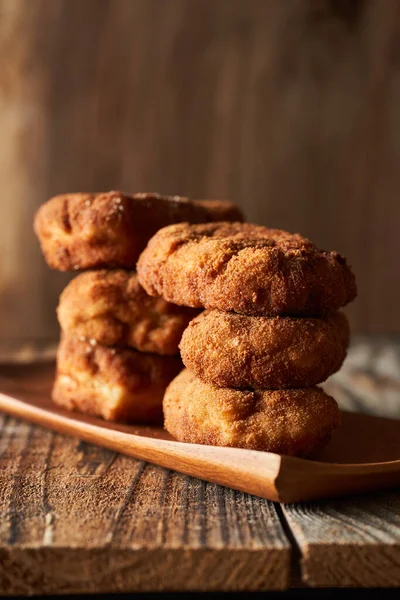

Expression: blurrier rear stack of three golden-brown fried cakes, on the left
xmin=35 ymin=192 xmax=241 ymax=422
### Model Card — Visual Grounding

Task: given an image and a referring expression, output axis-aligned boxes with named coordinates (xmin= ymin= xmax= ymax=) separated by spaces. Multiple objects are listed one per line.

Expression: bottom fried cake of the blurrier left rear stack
xmin=52 ymin=337 xmax=182 ymax=423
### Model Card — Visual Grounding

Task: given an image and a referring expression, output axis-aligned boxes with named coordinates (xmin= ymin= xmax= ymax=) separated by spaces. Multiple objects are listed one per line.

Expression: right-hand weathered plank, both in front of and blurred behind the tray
xmin=283 ymin=366 xmax=400 ymax=587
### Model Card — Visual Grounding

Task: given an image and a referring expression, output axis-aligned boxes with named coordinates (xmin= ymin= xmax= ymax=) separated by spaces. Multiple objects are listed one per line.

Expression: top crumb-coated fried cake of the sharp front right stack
xmin=137 ymin=223 xmax=357 ymax=316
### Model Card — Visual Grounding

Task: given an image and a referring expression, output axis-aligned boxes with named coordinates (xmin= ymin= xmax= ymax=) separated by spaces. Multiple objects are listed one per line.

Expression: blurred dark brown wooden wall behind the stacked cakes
xmin=0 ymin=0 xmax=400 ymax=342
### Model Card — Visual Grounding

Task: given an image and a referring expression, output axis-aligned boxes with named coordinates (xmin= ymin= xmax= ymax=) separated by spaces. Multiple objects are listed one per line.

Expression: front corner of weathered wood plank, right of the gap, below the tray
xmin=283 ymin=492 xmax=400 ymax=587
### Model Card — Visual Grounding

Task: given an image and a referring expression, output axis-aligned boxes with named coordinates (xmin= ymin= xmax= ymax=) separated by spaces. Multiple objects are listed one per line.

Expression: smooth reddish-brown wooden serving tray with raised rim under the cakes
xmin=0 ymin=363 xmax=400 ymax=502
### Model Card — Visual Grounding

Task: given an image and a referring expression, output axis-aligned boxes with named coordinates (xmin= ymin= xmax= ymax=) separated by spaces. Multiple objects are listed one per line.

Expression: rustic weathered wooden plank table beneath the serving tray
xmin=0 ymin=338 xmax=400 ymax=595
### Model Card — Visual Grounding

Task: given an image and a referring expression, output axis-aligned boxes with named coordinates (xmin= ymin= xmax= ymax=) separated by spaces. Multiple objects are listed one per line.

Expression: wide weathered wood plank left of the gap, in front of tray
xmin=0 ymin=417 xmax=290 ymax=594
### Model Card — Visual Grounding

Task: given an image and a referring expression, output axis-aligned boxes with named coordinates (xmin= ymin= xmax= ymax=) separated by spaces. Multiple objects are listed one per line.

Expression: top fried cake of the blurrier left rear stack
xmin=34 ymin=191 xmax=217 ymax=271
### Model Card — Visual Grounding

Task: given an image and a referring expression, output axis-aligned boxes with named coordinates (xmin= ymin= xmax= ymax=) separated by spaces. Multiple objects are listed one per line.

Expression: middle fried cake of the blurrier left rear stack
xmin=57 ymin=269 xmax=198 ymax=355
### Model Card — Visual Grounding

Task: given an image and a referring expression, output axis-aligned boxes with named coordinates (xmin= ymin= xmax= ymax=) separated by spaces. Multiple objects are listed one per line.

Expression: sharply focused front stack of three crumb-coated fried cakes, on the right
xmin=138 ymin=223 xmax=357 ymax=456
